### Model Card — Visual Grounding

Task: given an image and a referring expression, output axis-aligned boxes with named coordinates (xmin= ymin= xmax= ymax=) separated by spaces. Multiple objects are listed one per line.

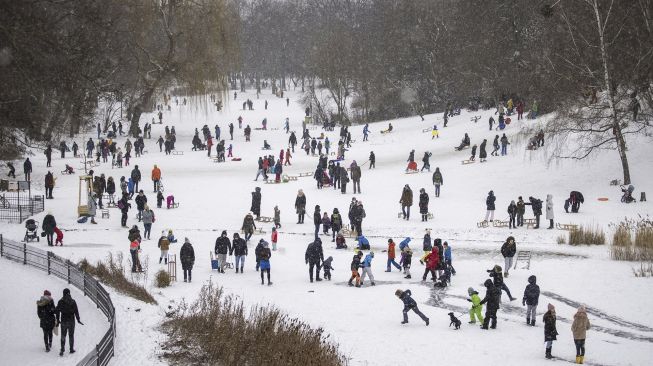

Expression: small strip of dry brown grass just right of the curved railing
xmin=79 ymin=253 xmax=157 ymax=304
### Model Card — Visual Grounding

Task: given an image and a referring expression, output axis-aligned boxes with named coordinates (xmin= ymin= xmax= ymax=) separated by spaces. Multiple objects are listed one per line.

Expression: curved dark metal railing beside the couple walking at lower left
xmin=0 ymin=234 xmax=116 ymax=366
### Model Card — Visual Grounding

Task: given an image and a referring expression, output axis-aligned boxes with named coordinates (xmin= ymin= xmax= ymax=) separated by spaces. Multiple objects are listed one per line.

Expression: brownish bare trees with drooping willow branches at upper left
xmin=0 ymin=0 xmax=238 ymax=155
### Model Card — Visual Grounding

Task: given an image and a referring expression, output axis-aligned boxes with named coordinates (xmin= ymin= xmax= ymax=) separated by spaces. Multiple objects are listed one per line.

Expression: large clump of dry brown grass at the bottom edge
xmin=163 ymin=283 xmax=347 ymax=366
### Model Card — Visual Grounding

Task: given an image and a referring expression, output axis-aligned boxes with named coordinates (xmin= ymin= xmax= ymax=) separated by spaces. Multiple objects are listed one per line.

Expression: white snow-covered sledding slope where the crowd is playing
xmin=0 ymin=91 xmax=653 ymax=365
